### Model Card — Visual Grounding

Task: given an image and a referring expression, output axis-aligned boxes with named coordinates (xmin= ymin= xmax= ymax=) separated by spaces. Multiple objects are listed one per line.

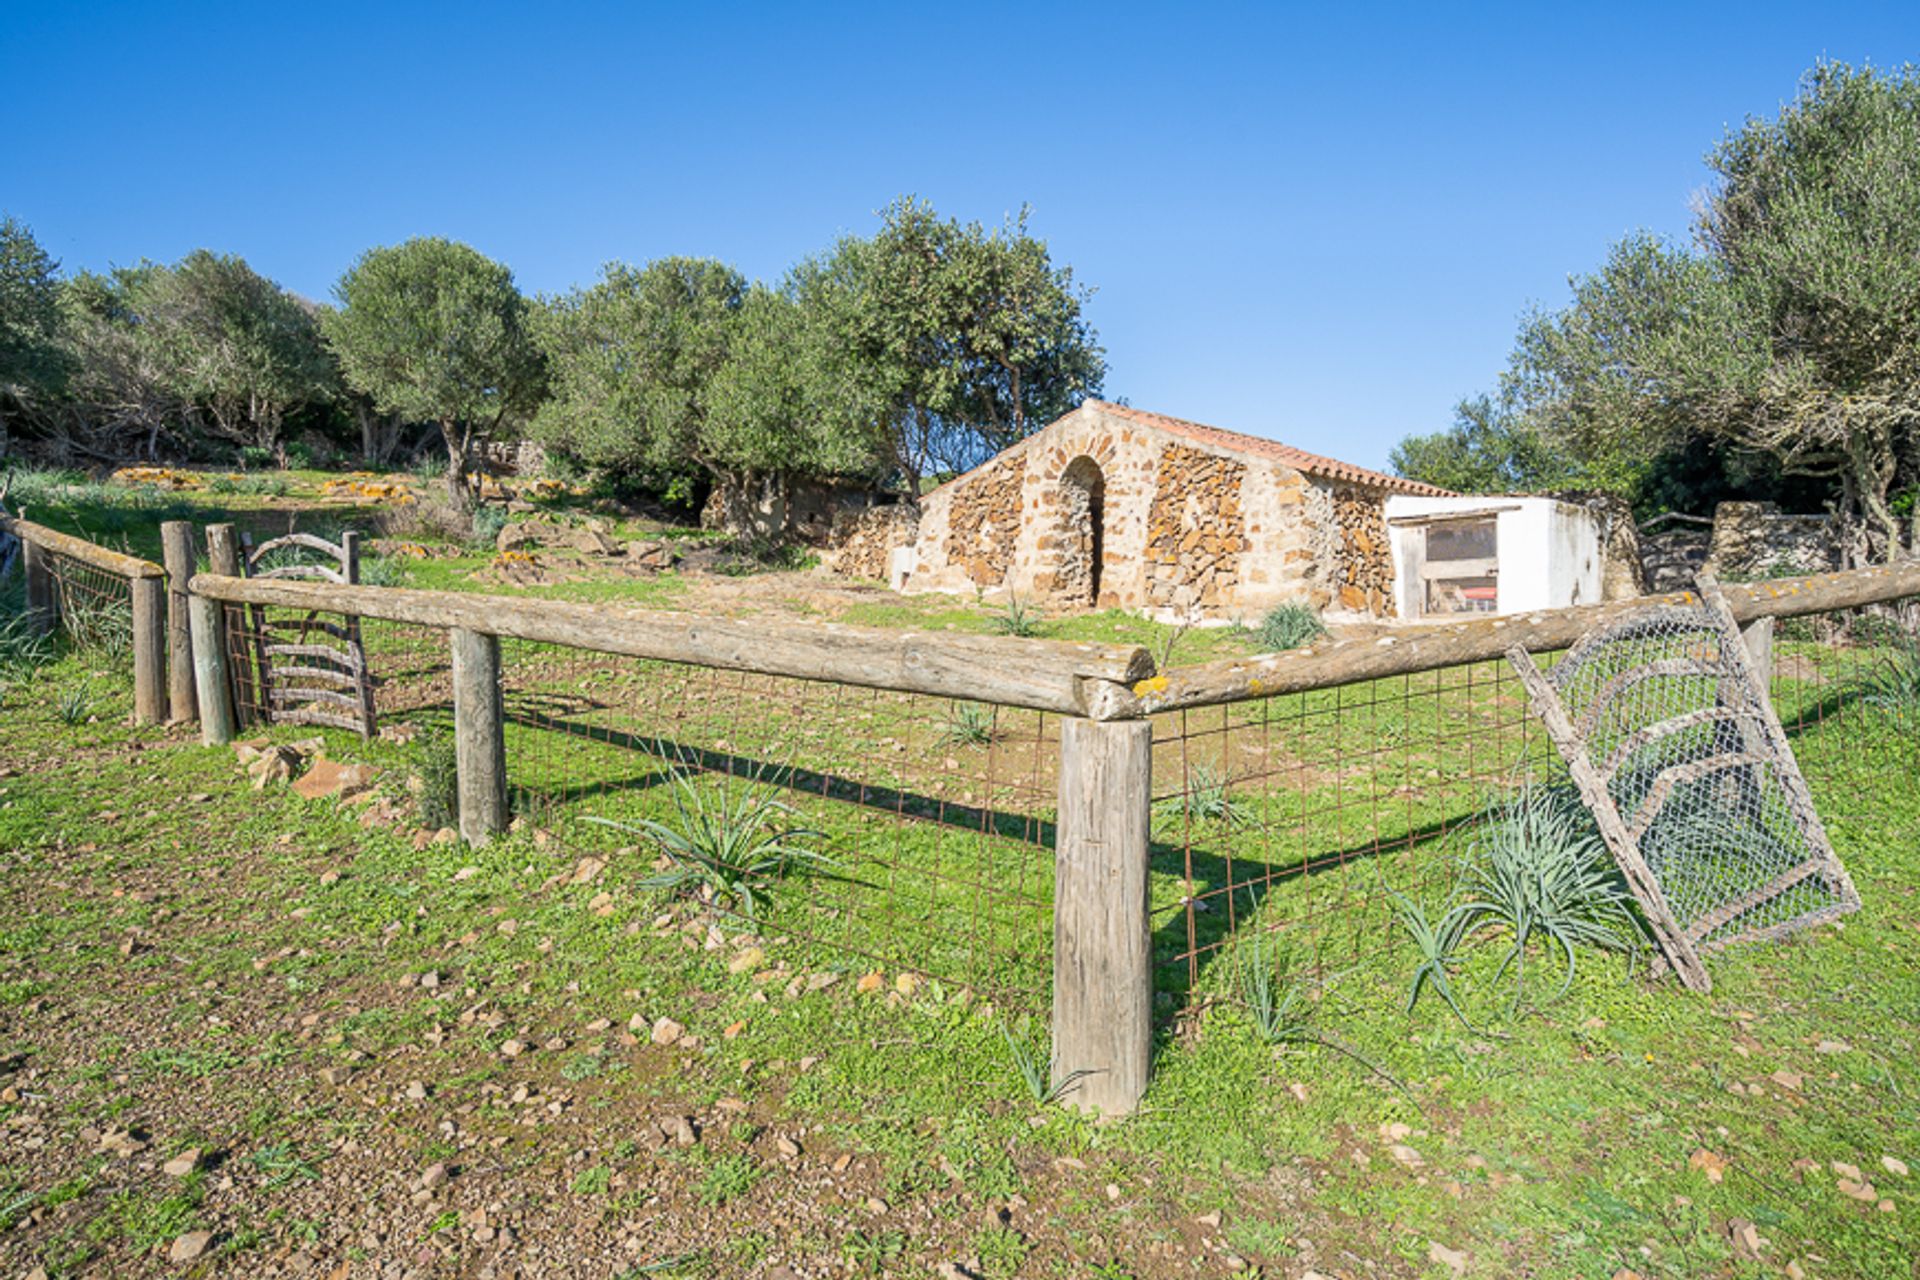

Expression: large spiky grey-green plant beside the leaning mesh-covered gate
xmin=1455 ymin=787 xmax=1645 ymax=1007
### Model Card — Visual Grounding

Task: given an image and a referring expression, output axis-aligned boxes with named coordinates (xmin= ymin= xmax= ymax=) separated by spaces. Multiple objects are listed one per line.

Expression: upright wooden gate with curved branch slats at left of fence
xmin=240 ymin=532 xmax=374 ymax=737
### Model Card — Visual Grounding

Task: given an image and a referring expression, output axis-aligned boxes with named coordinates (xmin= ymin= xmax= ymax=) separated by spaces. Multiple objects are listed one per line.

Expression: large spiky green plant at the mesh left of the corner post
xmin=593 ymin=760 xmax=837 ymax=921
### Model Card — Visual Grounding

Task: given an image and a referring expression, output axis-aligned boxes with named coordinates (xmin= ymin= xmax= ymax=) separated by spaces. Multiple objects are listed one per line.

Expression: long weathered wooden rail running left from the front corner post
xmin=190 ymin=574 xmax=1154 ymax=720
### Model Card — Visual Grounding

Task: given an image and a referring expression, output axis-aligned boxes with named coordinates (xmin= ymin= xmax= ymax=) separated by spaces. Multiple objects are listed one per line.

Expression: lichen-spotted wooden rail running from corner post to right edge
xmin=1133 ymin=560 xmax=1920 ymax=714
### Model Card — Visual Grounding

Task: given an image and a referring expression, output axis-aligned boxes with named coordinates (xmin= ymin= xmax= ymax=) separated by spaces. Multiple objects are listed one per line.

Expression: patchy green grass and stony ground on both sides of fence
xmin=0 ymin=466 xmax=1920 ymax=1280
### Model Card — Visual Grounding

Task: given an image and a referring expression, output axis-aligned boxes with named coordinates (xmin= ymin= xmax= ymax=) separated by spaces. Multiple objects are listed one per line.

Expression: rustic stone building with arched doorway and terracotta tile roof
xmin=867 ymin=399 xmax=1446 ymax=618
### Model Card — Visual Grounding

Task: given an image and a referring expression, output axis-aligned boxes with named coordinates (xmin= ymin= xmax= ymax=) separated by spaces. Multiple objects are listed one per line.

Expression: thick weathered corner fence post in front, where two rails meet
xmin=1054 ymin=718 xmax=1154 ymax=1115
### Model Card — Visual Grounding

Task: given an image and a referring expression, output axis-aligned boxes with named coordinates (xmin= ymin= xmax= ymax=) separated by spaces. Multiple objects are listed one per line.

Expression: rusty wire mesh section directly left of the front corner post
xmin=503 ymin=643 xmax=1058 ymax=1009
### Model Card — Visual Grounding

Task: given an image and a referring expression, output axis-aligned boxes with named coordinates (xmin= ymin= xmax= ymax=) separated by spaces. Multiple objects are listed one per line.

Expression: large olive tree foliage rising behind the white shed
xmin=1396 ymin=63 xmax=1920 ymax=560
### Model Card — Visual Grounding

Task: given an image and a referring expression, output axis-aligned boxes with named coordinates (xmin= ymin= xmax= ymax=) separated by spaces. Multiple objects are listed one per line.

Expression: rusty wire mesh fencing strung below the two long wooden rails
xmin=206 ymin=587 xmax=1920 ymax=1013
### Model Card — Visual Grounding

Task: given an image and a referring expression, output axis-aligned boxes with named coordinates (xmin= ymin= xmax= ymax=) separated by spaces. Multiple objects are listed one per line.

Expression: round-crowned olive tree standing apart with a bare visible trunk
xmin=323 ymin=236 xmax=543 ymax=510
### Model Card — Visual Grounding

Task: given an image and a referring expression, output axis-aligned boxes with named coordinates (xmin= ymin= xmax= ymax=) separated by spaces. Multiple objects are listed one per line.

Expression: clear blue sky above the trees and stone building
xmin=0 ymin=0 xmax=1920 ymax=464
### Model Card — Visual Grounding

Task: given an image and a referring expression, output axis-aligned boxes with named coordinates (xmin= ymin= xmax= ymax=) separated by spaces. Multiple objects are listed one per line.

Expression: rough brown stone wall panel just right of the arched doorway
xmin=1146 ymin=443 xmax=1250 ymax=610
